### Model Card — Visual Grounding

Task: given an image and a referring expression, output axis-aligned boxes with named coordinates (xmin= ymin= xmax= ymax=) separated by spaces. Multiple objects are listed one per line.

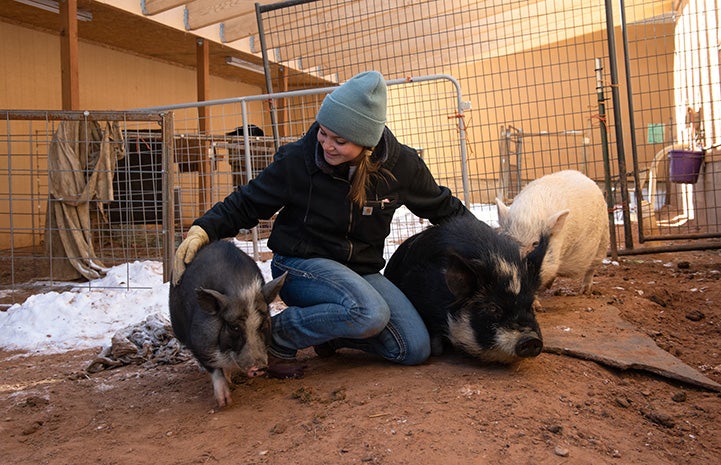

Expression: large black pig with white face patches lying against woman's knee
xmin=384 ymin=215 xmax=548 ymax=363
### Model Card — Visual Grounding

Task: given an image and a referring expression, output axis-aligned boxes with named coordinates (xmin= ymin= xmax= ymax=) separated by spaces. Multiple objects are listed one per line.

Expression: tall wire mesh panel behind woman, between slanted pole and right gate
xmin=259 ymin=1 xmax=612 ymax=192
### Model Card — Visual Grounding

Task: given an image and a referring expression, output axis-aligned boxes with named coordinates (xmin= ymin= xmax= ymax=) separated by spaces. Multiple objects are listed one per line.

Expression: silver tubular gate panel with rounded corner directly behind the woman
xmin=146 ymin=75 xmax=468 ymax=260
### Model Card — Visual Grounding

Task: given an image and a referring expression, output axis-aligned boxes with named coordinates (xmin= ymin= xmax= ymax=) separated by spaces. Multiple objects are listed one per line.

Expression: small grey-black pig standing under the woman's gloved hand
xmin=169 ymin=240 xmax=285 ymax=407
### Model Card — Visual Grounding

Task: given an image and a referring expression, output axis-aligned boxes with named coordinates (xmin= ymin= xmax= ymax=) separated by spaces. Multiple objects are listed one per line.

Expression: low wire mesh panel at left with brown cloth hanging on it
xmin=0 ymin=111 xmax=173 ymax=307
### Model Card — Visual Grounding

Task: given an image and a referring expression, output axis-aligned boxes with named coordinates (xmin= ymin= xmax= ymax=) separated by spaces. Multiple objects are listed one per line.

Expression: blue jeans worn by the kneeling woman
xmin=270 ymin=255 xmax=431 ymax=365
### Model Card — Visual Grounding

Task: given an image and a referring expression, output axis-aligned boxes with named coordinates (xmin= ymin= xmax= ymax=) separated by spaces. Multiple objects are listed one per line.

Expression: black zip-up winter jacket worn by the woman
xmin=193 ymin=123 xmax=471 ymax=274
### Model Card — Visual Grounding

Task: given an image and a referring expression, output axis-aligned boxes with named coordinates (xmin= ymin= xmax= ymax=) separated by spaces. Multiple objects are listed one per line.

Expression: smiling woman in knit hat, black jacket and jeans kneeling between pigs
xmin=173 ymin=71 xmax=470 ymax=365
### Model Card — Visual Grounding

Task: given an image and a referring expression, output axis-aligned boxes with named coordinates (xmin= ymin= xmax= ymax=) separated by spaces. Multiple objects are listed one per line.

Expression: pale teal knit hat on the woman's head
xmin=315 ymin=71 xmax=387 ymax=147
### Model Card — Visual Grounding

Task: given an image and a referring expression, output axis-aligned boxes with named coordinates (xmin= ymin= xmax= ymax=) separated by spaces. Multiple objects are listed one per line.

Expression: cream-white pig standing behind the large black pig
xmin=496 ymin=170 xmax=609 ymax=305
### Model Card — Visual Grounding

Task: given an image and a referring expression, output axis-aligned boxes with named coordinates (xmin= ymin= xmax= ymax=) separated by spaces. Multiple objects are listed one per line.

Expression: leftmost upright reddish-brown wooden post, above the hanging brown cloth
xmin=60 ymin=0 xmax=80 ymax=110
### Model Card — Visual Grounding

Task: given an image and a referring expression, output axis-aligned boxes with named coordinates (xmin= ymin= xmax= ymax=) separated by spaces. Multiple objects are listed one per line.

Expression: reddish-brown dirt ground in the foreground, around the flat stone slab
xmin=0 ymin=251 xmax=721 ymax=465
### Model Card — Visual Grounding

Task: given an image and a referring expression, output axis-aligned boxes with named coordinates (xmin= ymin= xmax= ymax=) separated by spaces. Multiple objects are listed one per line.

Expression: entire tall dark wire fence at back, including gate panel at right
xmin=258 ymin=0 xmax=721 ymax=253
